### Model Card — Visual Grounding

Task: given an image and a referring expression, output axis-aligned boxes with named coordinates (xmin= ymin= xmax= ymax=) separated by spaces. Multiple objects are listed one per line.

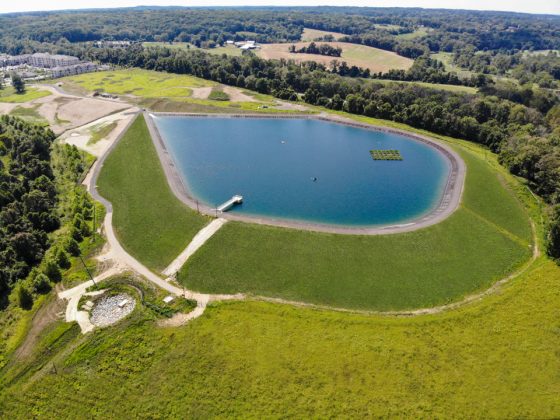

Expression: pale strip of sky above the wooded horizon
xmin=0 ymin=0 xmax=560 ymax=15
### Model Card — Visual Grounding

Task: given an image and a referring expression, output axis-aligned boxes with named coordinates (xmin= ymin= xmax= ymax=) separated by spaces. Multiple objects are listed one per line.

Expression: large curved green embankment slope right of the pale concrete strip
xmin=178 ymin=131 xmax=531 ymax=311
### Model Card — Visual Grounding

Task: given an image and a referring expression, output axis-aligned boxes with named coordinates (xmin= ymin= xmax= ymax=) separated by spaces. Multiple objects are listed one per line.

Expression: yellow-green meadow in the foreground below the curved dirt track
xmin=0 ymin=251 xmax=560 ymax=419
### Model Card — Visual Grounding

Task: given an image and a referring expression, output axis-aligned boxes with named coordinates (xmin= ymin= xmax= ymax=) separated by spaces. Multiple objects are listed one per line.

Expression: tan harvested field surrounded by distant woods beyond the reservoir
xmin=257 ymin=42 xmax=412 ymax=73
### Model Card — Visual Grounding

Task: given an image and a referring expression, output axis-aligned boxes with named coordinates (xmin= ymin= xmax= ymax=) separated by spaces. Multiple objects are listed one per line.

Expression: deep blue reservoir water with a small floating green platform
xmin=154 ymin=116 xmax=449 ymax=226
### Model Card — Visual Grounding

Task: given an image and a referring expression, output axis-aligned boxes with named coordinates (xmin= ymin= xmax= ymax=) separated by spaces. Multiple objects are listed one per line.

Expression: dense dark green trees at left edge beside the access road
xmin=0 ymin=115 xmax=94 ymax=309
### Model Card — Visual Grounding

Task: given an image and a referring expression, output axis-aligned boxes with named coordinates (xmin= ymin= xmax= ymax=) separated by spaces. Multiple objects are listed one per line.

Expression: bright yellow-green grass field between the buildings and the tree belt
xmin=63 ymin=69 xmax=216 ymax=100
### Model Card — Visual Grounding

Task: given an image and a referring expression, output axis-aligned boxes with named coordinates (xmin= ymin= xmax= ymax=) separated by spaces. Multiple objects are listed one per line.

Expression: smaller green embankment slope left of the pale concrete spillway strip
xmin=98 ymin=117 xmax=208 ymax=271
